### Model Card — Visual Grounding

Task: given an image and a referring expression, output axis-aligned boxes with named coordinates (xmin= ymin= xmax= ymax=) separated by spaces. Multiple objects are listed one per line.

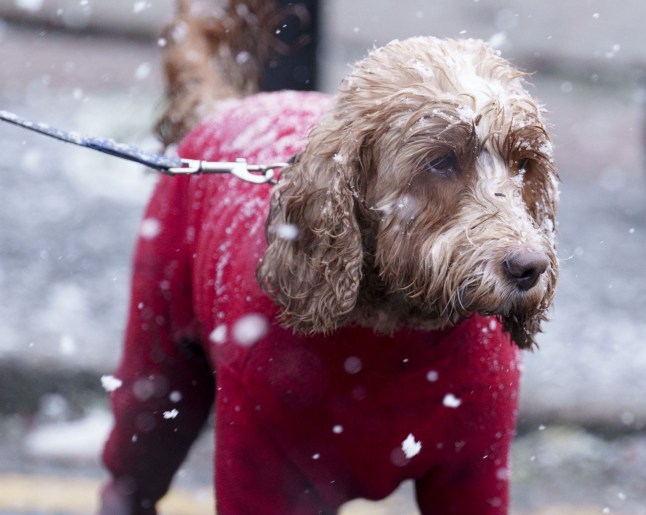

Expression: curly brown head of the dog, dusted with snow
xmin=258 ymin=38 xmax=558 ymax=347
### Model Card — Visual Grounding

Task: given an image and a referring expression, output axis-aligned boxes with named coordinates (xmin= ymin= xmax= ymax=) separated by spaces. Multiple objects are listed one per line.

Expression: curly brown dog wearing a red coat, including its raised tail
xmin=102 ymin=2 xmax=558 ymax=515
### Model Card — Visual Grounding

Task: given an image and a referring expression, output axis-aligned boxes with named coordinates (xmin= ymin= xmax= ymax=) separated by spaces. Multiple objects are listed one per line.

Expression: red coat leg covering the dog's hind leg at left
xmin=101 ymin=177 xmax=214 ymax=514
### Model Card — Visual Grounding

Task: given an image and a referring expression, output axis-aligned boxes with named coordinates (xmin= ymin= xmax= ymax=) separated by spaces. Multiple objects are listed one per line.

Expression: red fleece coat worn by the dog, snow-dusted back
xmin=103 ymin=92 xmax=519 ymax=515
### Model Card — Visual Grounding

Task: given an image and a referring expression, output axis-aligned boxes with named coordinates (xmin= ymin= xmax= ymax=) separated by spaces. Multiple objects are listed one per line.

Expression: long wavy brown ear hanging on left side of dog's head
xmin=257 ymin=118 xmax=366 ymax=333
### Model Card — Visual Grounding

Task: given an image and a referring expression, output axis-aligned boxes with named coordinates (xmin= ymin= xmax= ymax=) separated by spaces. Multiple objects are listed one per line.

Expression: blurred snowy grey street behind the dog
xmin=0 ymin=0 xmax=646 ymax=515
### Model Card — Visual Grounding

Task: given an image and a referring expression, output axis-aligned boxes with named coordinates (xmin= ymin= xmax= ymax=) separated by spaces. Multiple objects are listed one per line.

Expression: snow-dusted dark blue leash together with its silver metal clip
xmin=0 ymin=111 xmax=288 ymax=184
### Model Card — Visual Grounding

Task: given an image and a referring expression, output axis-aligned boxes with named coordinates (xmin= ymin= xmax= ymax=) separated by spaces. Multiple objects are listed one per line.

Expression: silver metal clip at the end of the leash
xmin=168 ymin=158 xmax=289 ymax=184
